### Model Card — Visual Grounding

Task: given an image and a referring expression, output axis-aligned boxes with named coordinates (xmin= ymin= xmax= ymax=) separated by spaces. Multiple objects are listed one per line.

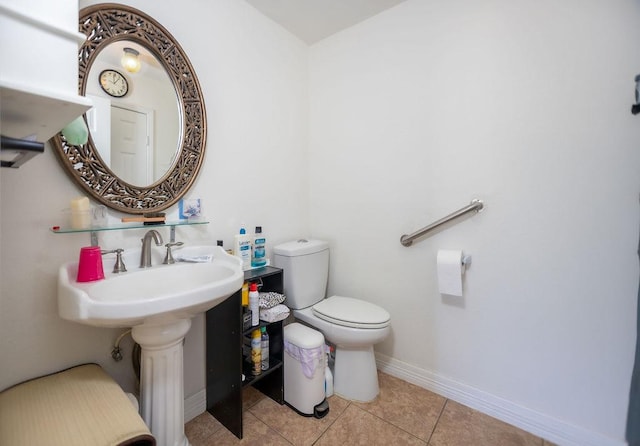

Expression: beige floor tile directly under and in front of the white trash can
xmin=250 ymin=396 xmax=349 ymax=446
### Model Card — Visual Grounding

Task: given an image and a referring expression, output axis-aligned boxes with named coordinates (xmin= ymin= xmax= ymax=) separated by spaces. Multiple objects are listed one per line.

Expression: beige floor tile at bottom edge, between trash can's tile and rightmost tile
xmin=315 ymin=404 xmax=427 ymax=446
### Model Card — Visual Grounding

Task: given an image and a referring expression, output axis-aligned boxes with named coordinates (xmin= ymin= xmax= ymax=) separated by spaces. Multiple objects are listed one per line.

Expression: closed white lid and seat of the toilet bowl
xmin=312 ymin=296 xmax=391 ymax=328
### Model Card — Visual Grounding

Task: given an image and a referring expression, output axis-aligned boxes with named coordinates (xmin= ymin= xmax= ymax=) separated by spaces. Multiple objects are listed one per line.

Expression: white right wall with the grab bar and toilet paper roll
xmin=309 ymin=0 xmax=640 ymax=445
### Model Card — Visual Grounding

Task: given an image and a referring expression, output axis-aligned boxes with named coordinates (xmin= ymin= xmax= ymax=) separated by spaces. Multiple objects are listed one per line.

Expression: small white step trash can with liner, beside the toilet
xmin=284 ymin=322 xmax=329 ymax=418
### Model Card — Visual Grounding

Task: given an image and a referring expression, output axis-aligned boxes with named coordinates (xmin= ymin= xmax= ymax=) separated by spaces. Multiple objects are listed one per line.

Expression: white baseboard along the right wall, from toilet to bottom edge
xmin=376 ymin=353 xmax=627 ymax=446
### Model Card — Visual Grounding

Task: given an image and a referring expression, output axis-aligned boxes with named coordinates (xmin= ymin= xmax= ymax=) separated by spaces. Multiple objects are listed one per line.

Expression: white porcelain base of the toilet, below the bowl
xmin=333 ymin=346 xmax=380 ymax=403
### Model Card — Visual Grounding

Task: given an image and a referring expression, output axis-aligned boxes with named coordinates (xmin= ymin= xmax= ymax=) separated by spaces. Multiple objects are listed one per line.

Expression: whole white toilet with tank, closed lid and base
xmin=273 ymin=239 xmax=391 ymax=402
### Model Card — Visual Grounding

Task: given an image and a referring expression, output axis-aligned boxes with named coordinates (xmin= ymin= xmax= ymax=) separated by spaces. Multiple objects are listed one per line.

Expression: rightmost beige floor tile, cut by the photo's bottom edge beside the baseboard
xmin=429 ymin=400 xmax=542 ymax=446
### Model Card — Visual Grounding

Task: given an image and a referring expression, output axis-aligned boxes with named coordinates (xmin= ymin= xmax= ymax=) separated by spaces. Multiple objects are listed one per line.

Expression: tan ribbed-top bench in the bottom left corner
xmin=0 ymin=364 xmax=156 ymax=446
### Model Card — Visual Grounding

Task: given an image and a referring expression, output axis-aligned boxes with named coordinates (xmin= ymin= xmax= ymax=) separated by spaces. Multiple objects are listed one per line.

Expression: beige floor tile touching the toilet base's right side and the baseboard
xmin=354 ymin=373 xmax=446 ymax=441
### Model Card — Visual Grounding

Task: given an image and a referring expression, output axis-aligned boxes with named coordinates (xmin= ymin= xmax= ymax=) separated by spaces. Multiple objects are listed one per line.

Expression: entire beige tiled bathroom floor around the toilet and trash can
xmin=185 ymin=373 xmax=553 ymax=446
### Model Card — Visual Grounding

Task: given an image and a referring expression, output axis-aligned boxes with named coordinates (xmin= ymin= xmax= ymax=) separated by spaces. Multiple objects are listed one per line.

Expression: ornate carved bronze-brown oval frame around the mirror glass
xmin=52 ymin=3 xmax=207 ymax=214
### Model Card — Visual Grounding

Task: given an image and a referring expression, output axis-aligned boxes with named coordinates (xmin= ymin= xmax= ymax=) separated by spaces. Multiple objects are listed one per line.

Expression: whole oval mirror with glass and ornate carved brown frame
xmin=52 ymin=3 xmax=207 ymax=214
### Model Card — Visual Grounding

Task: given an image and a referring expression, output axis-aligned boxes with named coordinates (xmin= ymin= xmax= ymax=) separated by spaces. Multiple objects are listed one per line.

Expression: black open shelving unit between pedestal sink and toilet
xmin=206 ymin=266 xmax=284 ymax=439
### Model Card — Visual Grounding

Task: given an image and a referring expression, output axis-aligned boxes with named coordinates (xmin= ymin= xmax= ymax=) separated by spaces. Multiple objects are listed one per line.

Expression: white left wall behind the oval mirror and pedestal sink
xmin=0 ymin=0 xmax=308 ymax=404
